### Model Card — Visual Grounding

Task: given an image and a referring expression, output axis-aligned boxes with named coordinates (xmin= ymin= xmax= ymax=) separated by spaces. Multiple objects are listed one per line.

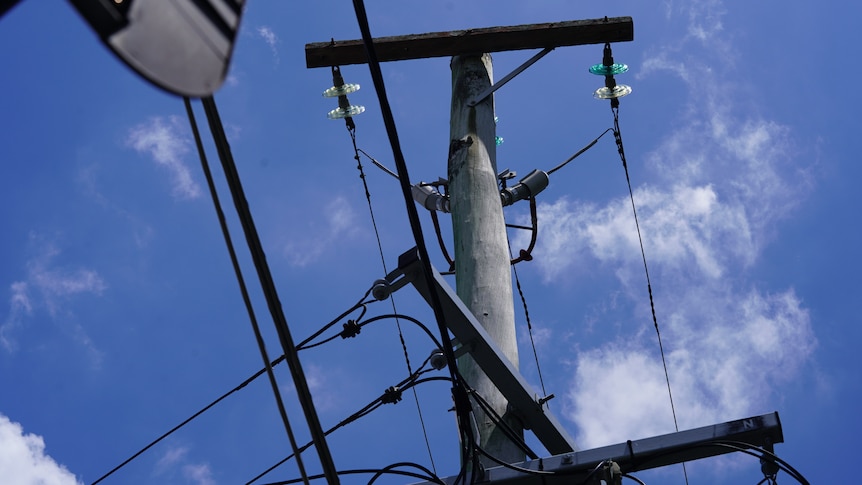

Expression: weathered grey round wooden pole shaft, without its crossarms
xmin=449 ymin=54 xmax=524 ymax=467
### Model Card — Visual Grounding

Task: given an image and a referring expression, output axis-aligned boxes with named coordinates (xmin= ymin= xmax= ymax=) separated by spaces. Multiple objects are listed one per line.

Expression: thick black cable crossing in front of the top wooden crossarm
xmin=353 ymin=0 xmax=480 ymax=466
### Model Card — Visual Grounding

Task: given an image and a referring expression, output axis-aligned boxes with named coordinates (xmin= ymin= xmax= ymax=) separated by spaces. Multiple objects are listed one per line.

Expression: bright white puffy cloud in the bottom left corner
xmin=0 ymin=414 xmax=81 ymax=485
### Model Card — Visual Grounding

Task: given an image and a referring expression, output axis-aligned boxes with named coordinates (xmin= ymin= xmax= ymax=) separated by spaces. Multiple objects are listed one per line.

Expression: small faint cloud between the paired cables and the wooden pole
xmin=284 ymin=197 xmax=358 ymax=267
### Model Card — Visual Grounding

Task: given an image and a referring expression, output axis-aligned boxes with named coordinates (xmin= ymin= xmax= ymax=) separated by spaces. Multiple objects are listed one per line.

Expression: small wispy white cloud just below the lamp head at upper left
xmin=126 ymin=116 xmax=201 ymax=199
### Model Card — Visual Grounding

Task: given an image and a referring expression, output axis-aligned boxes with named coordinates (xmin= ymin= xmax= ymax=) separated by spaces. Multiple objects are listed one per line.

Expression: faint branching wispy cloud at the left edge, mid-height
xmin=0 ymin=235 xmax=107 ymax=363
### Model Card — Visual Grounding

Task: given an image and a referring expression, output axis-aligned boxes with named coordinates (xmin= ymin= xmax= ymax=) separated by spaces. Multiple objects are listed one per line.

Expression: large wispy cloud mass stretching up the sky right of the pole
xmin=520 ymin=0 xmax=816 ymax=447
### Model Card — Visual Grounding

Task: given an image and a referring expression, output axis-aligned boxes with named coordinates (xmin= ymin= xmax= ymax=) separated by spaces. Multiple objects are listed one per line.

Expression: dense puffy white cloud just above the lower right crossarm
xmin=568 ymin=290 xmax=815 ymax=448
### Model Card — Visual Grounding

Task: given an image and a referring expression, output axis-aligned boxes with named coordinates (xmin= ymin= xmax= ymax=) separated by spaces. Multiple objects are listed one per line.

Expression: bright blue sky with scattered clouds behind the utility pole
xmin=0 ymin=0 xmax=862 ymax=485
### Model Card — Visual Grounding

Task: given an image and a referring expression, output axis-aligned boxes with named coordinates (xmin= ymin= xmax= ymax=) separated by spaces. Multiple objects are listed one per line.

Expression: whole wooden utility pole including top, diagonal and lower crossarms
xmin=305 ymin=17 xmax=808 ymax=485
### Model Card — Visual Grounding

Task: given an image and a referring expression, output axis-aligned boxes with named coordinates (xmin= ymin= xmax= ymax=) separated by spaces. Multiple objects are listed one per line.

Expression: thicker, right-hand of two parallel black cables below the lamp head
xmin=201 ymin=96 xmax=339 ymax=485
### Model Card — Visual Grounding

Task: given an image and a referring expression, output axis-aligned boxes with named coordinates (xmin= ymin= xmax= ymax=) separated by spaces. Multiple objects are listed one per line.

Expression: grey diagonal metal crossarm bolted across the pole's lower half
xmin=386 ymin=248 xmax=578 ymax=455
